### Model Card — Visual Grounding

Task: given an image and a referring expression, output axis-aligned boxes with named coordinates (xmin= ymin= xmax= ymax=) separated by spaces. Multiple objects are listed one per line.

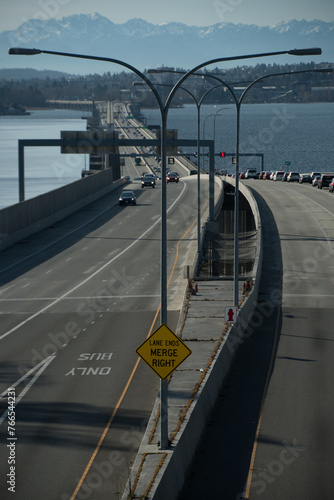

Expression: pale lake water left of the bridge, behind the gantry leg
xmin=0 ymin=110 xmax=90 ymax=209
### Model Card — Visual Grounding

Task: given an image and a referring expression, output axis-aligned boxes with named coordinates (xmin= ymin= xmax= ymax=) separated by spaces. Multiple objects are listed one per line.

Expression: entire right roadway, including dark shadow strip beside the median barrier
xmin=180 ymin=180 xmax=334 ymax=500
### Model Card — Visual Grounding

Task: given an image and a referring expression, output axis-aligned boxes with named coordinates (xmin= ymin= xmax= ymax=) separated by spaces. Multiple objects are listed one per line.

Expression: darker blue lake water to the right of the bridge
xmin=142 ymin=103 xmax=334 ymax=173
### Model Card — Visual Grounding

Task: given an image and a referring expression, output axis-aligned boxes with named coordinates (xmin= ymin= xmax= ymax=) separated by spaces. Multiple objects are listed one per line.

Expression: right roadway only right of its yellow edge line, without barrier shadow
xmin=244 ymin=181 xmax=334 ymax=500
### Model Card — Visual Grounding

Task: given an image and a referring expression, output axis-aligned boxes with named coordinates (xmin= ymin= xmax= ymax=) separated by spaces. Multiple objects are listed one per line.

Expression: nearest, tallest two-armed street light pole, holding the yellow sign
xmin=8 ymin=44 xmax=321 ymax=449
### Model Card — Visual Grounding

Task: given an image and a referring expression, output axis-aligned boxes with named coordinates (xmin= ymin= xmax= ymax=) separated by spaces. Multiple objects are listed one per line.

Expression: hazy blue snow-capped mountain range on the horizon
xmin=0 ymin=13 xmax=334 ymax=74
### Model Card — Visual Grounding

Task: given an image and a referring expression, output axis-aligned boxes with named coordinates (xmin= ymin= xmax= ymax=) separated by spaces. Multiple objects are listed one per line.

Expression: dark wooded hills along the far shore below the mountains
xmin=0 ymin=62 xmax=334 ymax=114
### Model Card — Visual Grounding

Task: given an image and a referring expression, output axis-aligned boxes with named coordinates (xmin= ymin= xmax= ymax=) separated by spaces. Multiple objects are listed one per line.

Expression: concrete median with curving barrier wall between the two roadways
xmin=122 ymin=179 xmax=262 ymax=500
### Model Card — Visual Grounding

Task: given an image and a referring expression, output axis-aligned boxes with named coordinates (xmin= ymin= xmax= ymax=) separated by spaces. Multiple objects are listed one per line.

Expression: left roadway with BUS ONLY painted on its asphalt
xmin=0 ymin=138 xmax=208 ymax=500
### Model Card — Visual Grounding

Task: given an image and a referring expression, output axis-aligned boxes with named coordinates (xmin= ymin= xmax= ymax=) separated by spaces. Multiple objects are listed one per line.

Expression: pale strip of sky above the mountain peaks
xmin=0 ymin=0 xmax=334 ymax=31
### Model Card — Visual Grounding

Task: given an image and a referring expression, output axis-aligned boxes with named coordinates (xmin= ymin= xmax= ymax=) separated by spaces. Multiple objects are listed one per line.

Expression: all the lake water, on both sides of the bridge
xmin=0 ymin=103 xmax=334 ymax=208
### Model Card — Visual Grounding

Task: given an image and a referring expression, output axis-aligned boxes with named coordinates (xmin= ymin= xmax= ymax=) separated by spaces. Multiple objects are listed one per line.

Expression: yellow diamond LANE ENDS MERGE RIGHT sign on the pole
xmin=136 ymin=324 xmax=191 ymax=380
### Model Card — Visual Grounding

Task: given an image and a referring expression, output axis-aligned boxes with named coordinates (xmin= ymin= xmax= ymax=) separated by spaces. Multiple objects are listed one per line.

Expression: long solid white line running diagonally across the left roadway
xmin=0 ymin=183 xmax=186 ymax=340
